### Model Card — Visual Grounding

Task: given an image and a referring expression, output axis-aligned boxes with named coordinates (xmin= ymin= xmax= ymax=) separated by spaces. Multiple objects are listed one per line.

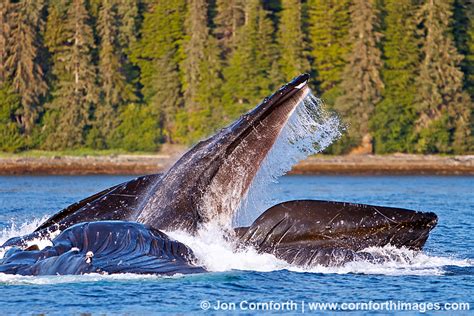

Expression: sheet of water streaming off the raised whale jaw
xmin=233 ymin=92 xmax=343 ymax=227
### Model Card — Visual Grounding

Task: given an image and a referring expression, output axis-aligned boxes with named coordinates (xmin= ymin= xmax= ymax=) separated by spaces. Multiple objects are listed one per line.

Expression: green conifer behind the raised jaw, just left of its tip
xmin=223 ymin=0 xmax=276 ymax=119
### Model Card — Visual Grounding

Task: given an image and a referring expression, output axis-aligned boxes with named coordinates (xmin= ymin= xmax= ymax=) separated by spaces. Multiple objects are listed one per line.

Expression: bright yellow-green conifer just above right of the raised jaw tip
xmin=308 ymin=0 xmax=351 ymax=105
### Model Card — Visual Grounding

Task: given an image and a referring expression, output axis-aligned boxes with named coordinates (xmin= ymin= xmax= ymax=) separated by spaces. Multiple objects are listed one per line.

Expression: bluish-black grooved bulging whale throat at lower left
xmin=0 ymin=221 xmax=205 ymax=275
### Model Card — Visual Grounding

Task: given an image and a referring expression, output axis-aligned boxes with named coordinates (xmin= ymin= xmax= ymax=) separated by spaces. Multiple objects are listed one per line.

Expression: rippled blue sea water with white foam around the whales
xmin=0 ymin=176 xmax=474 ymax=315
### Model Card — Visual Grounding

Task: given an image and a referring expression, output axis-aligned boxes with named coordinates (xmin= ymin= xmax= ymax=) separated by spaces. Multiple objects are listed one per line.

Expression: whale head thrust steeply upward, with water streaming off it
xmin=137 ymin=74 xmax=309 ymax=231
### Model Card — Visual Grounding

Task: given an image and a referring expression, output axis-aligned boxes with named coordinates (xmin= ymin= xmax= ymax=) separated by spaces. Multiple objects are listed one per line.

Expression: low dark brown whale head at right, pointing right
xmin=235 ymin=200 xmax=437 ymax=266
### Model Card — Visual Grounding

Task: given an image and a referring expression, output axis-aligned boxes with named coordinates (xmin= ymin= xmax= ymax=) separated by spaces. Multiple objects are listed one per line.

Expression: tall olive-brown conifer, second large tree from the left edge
xmin=44 ymin=0 xmax=98 ymax=149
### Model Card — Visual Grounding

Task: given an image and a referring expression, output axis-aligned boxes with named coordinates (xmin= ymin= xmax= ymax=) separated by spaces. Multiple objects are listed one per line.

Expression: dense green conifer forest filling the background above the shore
xmin=0 ymin=0 xmax=474 ymax=154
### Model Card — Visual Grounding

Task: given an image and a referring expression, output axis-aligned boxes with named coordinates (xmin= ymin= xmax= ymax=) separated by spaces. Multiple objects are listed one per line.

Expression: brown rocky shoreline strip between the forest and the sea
xmin=0 ymin=154 xmax=474 ymax=175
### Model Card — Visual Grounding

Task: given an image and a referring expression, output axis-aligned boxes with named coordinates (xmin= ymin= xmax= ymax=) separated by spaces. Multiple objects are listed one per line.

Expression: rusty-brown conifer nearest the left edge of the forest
xmin=5 ymin=0 xmax=47 ymax=135
